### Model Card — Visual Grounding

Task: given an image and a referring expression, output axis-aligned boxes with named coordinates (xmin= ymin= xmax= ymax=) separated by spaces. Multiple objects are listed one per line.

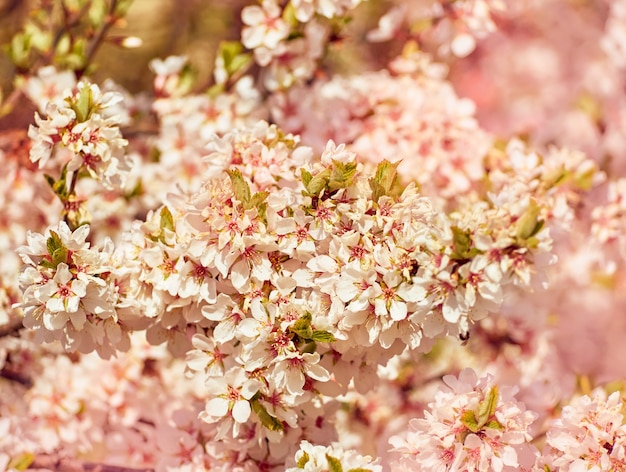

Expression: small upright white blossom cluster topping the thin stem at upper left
xmin=28 ymin=79 xmax=130 ymax=188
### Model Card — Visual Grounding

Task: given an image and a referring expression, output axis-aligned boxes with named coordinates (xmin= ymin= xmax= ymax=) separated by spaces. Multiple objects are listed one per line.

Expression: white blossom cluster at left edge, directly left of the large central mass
xmin=17 ymin=222 xmax=129 ymax=357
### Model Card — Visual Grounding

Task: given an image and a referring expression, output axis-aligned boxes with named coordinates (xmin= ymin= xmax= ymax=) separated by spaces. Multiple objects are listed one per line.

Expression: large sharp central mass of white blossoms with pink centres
xmin=96 ymin=122 xmax=550 ymax=464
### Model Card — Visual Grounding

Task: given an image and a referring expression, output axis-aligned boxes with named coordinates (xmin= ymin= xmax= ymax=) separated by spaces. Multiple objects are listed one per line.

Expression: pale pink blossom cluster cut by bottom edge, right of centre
xmin=390 ymin=369 xmax=538 ymax=472
